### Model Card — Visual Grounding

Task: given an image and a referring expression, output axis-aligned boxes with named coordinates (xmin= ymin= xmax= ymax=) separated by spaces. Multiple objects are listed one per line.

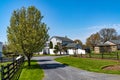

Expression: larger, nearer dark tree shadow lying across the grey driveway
xmin=40 ymin=63 xmax=68 ymax=69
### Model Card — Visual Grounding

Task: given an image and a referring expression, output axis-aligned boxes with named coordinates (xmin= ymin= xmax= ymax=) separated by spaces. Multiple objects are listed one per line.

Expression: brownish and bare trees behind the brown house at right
xmin=86 ymin=28 xmax=120 ymax=49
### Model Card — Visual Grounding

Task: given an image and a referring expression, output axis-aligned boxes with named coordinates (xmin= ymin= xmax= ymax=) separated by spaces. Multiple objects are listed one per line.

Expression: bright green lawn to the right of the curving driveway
xmin=55 ymin=57 xmax=120 ymax=74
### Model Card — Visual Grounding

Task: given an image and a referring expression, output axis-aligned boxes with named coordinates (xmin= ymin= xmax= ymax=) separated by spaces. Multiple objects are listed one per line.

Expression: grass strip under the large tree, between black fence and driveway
xmin=19 ymin=60 xmax=44 ymax=80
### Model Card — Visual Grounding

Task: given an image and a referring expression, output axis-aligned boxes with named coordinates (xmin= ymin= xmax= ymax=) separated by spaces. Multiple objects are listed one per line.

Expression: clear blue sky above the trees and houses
xmin=0 ymin=0 xmax=120 ymax=43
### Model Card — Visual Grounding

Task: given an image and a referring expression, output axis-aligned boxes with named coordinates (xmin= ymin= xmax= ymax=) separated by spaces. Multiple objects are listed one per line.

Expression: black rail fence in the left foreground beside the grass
xmin=1 ymin=57 xmax=24 ymax=80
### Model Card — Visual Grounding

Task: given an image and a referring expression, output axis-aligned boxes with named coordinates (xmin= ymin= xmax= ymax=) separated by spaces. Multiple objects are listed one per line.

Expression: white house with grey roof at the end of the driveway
xmin=43 ymin=36 xmax=85 ymax=55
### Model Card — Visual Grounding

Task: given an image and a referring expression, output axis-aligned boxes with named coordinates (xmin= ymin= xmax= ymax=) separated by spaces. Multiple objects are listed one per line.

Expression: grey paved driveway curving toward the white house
xmin=33 ymin=56 xmax=120 ymax=80
